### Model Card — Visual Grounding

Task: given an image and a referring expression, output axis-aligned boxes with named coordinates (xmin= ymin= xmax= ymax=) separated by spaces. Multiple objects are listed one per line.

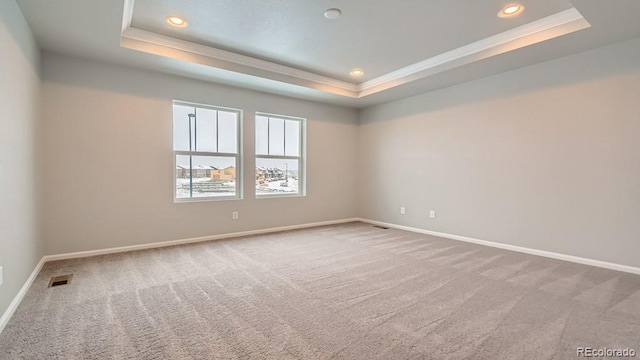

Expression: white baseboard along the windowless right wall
xmin=358 ymin=218 xmax=640 ymax=275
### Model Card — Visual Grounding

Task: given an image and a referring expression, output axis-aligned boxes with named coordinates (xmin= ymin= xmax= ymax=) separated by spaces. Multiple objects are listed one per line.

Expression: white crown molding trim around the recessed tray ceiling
xmin=120 ymin=0 xmax=591 ymax=98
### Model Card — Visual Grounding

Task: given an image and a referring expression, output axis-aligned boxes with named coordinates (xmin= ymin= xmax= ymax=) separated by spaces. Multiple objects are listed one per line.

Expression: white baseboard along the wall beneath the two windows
xmin=44 ymin=218 xmax=358 ymax=262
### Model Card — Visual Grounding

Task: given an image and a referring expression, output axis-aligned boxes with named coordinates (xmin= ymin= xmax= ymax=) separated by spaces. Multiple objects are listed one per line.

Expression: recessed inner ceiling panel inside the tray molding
xmin=131 ymin=0 xmax=572 ymax=81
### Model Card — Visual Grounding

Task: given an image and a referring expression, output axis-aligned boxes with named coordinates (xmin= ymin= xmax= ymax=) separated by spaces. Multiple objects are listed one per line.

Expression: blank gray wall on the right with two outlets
xmin=358 ymin=39 xmax=640 ymax=266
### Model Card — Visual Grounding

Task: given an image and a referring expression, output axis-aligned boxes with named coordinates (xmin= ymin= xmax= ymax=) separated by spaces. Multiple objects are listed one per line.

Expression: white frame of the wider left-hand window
xmin=171 ymin=100 xmax=244 ymax=203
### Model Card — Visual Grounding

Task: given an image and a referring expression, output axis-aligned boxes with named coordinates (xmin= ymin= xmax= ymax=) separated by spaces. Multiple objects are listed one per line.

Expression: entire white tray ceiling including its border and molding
xmin=17 ymin=0 xmax=640 ymax=107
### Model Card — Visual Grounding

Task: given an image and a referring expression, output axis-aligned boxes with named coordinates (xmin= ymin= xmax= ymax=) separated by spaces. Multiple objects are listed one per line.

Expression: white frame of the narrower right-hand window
xmin=253 ymin=112 xmax=307 ymax=199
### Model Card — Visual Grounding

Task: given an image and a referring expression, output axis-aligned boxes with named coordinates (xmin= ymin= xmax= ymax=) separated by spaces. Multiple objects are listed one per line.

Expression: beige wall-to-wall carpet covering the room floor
xmin=0 ymin=223 xmax=640 ymax=359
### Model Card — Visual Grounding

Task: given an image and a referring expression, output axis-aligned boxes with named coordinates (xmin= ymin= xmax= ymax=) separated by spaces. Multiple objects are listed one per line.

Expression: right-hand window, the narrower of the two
xmin=256 ymin=113 xmax=306 ymax=197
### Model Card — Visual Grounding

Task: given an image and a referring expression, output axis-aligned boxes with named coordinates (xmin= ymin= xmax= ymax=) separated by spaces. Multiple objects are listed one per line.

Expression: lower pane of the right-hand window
xmin=256 ymin=158 xmax=299 ymax=195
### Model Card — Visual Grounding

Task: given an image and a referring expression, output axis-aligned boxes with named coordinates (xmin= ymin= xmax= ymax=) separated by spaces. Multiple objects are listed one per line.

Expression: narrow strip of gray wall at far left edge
xmin=0 ymin=0 xmax=42 ymax=315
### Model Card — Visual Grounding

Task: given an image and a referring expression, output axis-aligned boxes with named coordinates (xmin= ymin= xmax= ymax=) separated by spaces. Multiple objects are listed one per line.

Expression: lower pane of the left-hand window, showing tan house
xmin=176 ymin=155 xmax=236 ymax=199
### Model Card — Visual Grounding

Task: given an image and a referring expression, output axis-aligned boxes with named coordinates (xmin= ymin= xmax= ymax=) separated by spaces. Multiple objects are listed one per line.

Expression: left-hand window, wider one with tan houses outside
xmin=173 ymin=101 xmax=242 ymax=201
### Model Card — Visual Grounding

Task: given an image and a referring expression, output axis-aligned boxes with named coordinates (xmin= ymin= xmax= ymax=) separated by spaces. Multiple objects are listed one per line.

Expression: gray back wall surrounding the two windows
xmin=42 ymin=53 xmax=357 ymax=254
